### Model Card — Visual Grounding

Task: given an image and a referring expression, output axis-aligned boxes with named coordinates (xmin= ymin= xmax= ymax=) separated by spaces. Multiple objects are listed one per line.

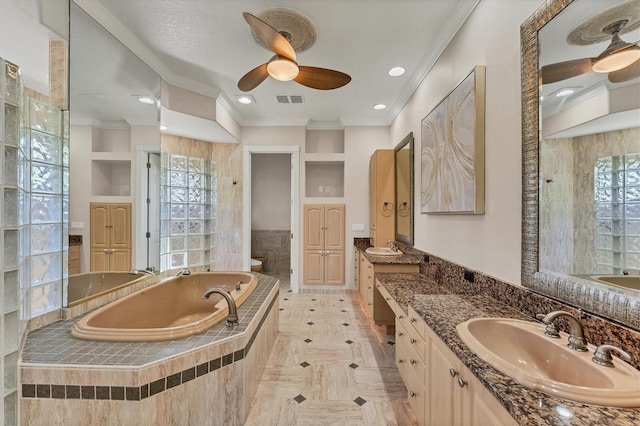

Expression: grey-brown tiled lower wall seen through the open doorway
xmin=251 ymin=229 xmax=291 ymax=272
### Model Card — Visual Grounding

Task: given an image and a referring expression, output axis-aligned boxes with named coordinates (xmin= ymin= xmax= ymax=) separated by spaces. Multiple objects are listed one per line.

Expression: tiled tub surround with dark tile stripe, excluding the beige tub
xmin=20 ymin=275 xmax=279 ymax=425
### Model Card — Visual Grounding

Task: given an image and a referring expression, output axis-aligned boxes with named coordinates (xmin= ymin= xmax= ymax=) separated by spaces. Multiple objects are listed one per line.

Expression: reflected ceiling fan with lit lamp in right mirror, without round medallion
xmin=541 ymin=19 xmax=640 ymax=84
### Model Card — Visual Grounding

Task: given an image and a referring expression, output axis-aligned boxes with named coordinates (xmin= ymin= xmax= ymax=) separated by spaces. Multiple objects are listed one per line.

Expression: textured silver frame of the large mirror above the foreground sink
xmin=520 ymin=0 xmax=640 ymax=330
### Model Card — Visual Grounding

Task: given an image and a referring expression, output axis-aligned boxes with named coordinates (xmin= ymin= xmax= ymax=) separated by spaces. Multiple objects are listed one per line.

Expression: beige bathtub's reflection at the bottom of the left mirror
xmin=68 ymin=272 xmax=148 ymax=307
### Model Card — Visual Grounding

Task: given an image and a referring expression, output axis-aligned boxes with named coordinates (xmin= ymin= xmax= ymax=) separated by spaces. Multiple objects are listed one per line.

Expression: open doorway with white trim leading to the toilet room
xmin=243 ymin=146 xmax=300 ymax=292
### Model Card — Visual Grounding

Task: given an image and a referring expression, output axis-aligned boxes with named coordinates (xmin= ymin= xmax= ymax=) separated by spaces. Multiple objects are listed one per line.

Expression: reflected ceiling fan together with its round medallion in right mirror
xmin=541 ymin=0 xmax=640 ymax=84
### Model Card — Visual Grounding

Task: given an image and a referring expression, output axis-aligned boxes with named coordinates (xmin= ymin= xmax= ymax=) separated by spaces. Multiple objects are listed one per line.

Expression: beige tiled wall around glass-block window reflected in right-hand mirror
xmin=540 ymin=128 xmax=640 ymax=274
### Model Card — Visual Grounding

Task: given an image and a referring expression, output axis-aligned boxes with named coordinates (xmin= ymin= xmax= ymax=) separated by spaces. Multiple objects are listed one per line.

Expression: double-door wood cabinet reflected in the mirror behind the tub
xmin=90 ymin=203 xmax=131 ymax=271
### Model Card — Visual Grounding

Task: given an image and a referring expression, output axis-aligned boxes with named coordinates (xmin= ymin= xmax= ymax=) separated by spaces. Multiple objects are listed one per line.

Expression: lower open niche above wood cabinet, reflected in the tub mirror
xmin=91 ymin=160 xmax=131 ymax=197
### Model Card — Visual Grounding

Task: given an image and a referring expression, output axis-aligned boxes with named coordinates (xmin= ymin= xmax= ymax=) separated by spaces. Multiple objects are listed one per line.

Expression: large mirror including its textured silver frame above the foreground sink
xmin=521 ymin=0 xmax=640 ymax=329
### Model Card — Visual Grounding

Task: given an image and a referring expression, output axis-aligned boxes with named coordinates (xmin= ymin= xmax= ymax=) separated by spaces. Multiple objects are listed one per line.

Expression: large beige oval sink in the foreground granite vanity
xmin=456 ymin=318 xmax=640 ymax=407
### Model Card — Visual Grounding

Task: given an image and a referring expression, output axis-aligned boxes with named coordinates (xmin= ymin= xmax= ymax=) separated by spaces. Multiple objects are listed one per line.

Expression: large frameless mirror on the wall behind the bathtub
xmin=63 ymin=0 xmax=160 ymax=306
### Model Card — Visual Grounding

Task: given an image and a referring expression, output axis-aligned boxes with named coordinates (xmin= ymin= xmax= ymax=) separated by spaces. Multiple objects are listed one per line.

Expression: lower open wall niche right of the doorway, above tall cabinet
xmin=305 ymin=161 xmax=344 ymax=197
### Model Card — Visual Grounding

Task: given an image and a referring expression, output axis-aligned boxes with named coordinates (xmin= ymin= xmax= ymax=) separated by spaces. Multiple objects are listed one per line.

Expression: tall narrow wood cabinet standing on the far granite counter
xmin=369 ymin=149 xmax=396 ymax=247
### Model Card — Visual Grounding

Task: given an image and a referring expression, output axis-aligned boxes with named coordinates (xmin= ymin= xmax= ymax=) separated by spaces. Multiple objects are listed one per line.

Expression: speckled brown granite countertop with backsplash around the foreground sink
xmin=376 ymin=266 xmax=640 ymax=425
